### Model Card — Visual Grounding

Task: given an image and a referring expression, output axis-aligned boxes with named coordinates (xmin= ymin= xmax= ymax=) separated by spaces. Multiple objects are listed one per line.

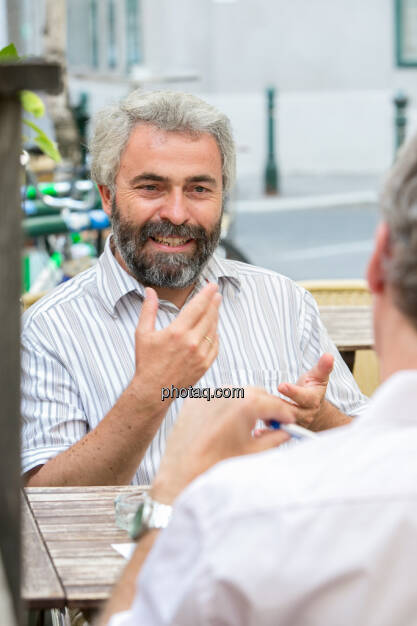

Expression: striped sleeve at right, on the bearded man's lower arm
xmin=301 ymin=291 xmax=367 ymax=416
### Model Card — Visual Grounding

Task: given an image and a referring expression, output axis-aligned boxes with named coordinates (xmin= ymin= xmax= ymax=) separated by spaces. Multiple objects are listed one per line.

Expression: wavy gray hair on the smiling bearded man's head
xmin=90 ymin=89 xmax=236 ymax=193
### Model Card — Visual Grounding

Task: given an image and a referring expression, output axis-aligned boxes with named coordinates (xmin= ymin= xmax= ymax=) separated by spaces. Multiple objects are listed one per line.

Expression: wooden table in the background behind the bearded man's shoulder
xmin=320 ymin=306 xmax=374 ymax=371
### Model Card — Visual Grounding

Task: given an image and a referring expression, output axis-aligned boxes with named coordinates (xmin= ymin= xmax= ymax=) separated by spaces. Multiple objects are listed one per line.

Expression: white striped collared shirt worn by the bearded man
xmin=22 ymin=238 xmax=366 ymax=484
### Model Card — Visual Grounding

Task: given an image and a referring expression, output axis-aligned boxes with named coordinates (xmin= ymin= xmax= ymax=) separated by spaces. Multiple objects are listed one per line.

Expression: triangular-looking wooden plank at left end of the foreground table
xmin=22 ymin=497 xmax=65 ymax=608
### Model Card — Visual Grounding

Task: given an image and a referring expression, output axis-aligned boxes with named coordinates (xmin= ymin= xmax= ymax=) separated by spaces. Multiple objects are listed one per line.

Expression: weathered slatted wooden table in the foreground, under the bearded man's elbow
xmin=22 ymin=486 xmax=147 ymax=609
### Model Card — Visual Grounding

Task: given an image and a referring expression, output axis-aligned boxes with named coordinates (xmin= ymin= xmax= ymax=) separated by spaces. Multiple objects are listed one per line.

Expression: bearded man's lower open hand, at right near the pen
xmin=278 ymin=353 xmax=334 ymax=430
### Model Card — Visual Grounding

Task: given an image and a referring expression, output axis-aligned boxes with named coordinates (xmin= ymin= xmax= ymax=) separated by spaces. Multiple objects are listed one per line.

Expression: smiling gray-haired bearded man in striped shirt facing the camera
xmin=22 ymin=91 xmax=365 ymax=486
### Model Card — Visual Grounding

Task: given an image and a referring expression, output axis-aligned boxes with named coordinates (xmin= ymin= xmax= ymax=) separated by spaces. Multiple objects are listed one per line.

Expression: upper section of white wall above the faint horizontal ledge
xmin=142 ymin=0 xmax=417 ymax=93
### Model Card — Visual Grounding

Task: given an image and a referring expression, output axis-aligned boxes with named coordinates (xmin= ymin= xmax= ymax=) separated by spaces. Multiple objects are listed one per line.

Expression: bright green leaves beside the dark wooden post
xmin=0 ymin=43 xmax=61 ymax=163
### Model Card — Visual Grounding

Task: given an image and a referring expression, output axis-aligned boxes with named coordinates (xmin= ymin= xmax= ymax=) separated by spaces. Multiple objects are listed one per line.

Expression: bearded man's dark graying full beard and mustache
xmin=111 ymin=199 xmax=221 ymax=289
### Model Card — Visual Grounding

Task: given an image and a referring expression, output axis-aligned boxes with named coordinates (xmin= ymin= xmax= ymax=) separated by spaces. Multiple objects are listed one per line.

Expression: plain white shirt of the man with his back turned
xmin=110 ymin=371 xmax=417 ymax=626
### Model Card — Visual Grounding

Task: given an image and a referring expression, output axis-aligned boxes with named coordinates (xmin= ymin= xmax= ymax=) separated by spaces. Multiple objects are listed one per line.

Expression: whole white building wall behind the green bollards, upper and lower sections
xmin=57 ymin=0 xmax=417 ymax=181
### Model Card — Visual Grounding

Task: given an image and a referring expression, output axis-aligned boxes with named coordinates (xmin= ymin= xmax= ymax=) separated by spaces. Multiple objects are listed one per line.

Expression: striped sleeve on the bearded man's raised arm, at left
xmin=21 ymin=322 xmax=88 ymax=473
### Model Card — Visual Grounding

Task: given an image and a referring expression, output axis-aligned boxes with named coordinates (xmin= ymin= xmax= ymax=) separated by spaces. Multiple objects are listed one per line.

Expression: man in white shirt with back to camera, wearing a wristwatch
xmin=100 ymin=136 xmax=417 ymax=626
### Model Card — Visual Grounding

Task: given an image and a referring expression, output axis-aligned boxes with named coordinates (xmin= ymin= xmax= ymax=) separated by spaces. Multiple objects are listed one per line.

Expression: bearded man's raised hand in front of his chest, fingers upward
xmin=132 ymin=283 xmax=221 ymax=399
